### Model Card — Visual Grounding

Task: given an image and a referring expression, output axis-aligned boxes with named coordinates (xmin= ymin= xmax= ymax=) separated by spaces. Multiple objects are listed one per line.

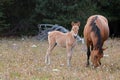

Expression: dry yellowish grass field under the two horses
xmin=0 ymin=38 xmax=120 ymax=80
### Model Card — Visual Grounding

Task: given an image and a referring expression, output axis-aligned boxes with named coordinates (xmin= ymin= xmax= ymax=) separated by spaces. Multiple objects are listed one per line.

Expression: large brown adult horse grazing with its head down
xmin=83 ymin=15 xmax=109 ymax=67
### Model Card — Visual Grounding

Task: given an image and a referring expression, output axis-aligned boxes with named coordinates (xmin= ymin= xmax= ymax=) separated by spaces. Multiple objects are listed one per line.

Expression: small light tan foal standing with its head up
xmin=45 ymin=22 xmax=80 ymax=66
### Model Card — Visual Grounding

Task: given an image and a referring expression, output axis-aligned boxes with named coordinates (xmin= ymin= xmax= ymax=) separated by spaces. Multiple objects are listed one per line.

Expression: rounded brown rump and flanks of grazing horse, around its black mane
xmin=84 ymin=15 xmax=109 ymax=45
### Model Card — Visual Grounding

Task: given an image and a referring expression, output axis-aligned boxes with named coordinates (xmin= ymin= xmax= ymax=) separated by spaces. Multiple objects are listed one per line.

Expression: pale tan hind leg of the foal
xmin=45 ymin=42 xmax=57 ymax=65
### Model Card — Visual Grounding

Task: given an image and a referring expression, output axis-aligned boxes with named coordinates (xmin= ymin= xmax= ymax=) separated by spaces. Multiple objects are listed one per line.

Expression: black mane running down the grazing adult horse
xmin=90 ymin=16 xmax=102 ymax=53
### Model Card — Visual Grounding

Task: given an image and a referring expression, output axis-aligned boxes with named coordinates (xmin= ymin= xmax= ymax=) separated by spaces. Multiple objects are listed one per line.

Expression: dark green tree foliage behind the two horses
xmin=0 ymin=0 xmax=120 ymax=36
